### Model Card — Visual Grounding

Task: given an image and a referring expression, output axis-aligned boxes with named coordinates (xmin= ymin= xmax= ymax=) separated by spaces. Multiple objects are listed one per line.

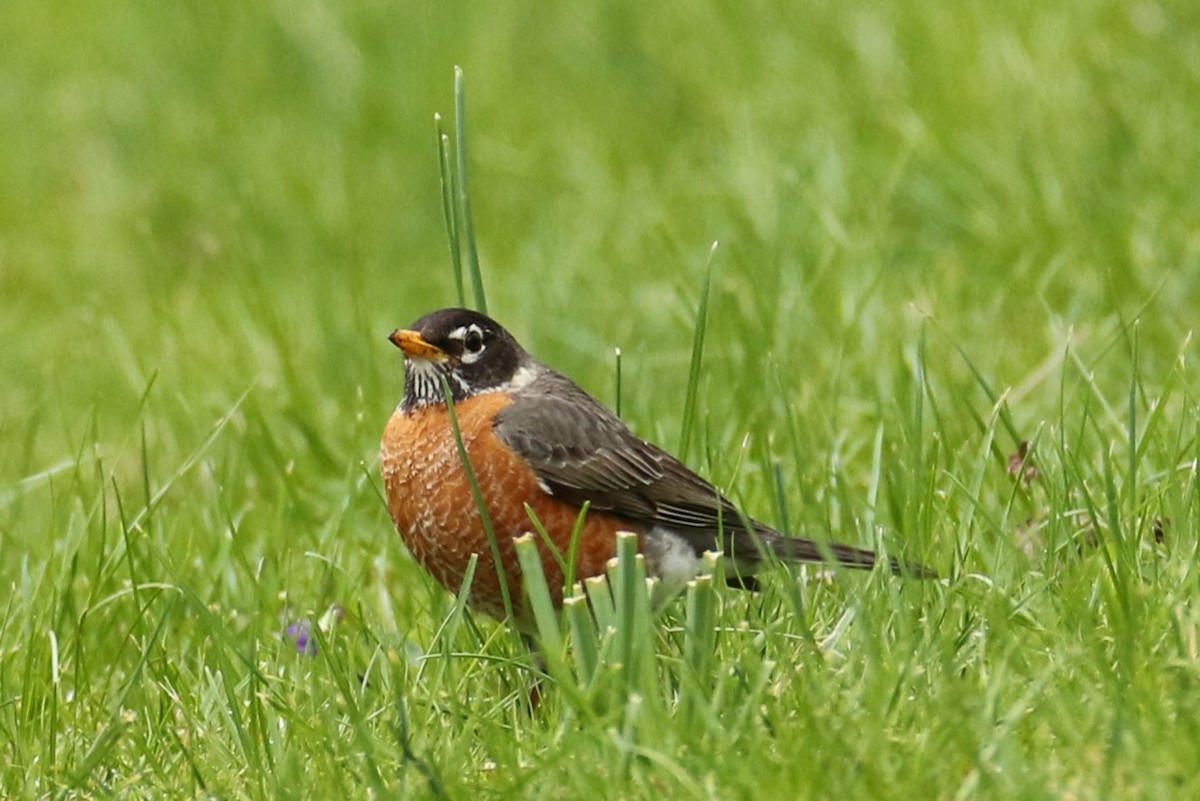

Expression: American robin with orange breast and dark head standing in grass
xmin=382 ymin=308 xmax=931 ymax=628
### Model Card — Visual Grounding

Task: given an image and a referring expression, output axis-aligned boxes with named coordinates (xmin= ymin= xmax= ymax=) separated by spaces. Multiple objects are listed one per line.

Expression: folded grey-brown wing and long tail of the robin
xmin=496 ymin=371 xmax=926 ymax=574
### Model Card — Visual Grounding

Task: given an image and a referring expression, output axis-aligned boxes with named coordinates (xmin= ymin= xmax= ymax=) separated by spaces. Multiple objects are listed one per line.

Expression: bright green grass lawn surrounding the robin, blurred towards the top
xmin=0 ymin=0 xmax=1200 ymax=799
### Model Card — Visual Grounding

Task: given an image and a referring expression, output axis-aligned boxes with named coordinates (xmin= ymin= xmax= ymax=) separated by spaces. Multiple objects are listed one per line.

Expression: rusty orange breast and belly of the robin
xmin=382 ymin=393 xmax=631 ymax=620
